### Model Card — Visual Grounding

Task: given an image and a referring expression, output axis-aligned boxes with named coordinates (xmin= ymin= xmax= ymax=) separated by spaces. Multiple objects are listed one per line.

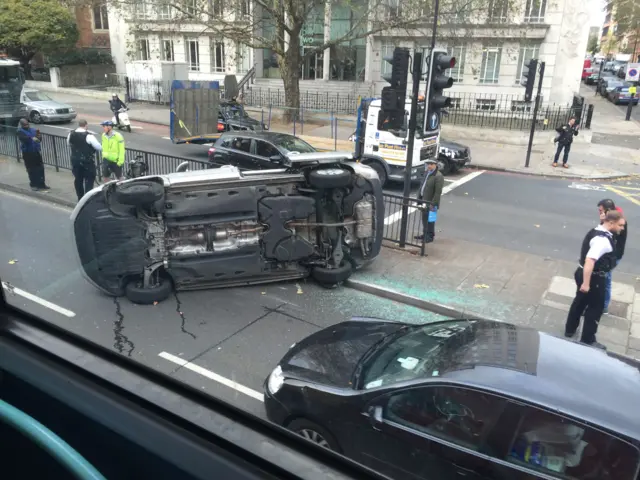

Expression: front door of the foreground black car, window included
xmin=360 ymin=385 xmax=506 ymax=480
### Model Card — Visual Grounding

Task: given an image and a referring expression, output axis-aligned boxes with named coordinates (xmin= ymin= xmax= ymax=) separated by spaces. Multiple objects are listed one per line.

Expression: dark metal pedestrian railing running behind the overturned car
xmin=0 ymin=128 xmax=428 ymax=255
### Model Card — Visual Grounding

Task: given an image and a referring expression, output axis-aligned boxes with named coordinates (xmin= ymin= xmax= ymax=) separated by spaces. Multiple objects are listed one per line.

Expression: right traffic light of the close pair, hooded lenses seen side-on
xmin=424 ymin=48 xmax=456 ymax=132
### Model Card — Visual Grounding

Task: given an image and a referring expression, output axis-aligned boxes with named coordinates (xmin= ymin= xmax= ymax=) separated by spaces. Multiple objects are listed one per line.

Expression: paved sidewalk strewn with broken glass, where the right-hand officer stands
xmin=349 ymin=242 xmax=640 ymax=357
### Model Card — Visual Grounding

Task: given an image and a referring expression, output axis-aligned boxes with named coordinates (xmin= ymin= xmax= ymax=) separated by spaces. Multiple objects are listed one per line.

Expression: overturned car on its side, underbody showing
xmin=71 ymin=152 xmax=384 ymax=304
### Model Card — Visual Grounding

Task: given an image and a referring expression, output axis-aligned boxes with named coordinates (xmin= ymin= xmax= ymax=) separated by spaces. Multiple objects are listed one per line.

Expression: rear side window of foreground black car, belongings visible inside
xmin=505 ymin=405 xmax=640 ymax=480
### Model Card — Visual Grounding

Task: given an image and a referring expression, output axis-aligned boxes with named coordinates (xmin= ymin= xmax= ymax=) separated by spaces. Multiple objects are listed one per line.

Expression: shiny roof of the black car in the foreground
xmin=410 ymin=320 xmax=640 ymax=440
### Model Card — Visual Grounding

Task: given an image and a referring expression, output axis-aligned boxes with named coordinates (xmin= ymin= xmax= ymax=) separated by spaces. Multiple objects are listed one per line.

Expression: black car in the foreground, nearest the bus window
xmin=264 ymin=318 xmax=640 ymax=480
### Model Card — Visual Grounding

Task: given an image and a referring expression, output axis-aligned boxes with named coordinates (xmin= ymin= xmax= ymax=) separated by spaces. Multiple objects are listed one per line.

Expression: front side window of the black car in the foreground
xmin=384 ymin=386 xmax=507 ymax=450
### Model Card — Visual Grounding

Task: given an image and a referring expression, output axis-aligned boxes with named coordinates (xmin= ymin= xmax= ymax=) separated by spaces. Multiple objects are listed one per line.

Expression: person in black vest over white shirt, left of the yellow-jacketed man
xmin=67 ymin=120 xmax=102 ymax=201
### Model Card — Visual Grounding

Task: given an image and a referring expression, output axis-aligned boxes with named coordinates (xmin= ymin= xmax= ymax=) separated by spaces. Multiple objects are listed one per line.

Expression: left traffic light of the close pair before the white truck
xmin=378 ymin=48 xmax=409 ymax=130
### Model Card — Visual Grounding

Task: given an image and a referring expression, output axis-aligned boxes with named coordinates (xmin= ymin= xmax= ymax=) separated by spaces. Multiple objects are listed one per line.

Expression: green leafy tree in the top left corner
xmin=0 ymin=0 xmax=79 ymax=76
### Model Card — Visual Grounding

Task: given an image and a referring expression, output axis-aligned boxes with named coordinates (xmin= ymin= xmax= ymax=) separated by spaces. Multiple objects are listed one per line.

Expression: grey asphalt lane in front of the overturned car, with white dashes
xmin=0 ymin=192 xmax=441 ymax=416
